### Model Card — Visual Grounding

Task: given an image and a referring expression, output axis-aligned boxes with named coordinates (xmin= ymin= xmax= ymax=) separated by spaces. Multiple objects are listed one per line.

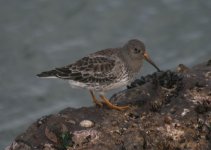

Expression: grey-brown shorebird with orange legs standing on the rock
xmin=37 ymin=39 xmax=160 ymax=111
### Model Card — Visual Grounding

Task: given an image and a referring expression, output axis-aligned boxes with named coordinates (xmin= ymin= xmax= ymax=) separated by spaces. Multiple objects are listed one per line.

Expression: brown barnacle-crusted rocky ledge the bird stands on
xmin=6 ymin=60 xmax=211 ymax=150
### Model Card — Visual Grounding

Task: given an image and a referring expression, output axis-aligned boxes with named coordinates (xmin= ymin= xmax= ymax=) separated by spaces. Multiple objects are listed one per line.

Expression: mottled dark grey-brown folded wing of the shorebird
xmin=38 ymin=55 xmax=116 ymax=83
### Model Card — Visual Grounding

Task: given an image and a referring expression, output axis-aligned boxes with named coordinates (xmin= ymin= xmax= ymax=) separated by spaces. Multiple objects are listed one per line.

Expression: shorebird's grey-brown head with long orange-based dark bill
xmin=123 ymin=39 xmax=160 ymax=71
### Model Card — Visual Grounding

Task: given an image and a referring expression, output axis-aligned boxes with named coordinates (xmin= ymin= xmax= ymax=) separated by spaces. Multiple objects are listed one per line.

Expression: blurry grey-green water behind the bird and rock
xmin=0 ymin=0 xmax=211 ymax=149
